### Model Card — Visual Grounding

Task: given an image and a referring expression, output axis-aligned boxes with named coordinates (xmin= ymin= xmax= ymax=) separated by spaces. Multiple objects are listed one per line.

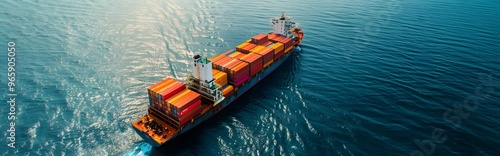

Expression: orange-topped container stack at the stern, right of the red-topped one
xmin=166 ymin=89 xmax=201 ymax=126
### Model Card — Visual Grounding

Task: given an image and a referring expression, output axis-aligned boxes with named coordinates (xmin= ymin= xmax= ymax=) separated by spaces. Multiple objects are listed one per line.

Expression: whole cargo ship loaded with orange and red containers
xmin=132 ymin=12 xmax=304 ymax=147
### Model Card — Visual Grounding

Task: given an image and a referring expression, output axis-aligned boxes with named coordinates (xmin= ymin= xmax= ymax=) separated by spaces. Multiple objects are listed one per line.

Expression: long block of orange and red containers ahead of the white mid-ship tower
xmin=211 ymin=34 xmax=294 ymax=92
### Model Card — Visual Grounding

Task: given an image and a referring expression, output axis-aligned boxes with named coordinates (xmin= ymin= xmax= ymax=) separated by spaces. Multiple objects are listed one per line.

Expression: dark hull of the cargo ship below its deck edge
xmin=134 ymin=47 xmax=297 ymax=147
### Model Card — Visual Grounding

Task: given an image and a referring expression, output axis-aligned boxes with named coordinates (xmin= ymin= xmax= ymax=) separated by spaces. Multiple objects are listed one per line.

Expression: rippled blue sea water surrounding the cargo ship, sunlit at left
xmin=0 ymin=0 xmax=500 ymax=155
